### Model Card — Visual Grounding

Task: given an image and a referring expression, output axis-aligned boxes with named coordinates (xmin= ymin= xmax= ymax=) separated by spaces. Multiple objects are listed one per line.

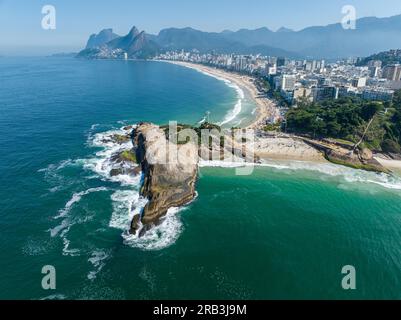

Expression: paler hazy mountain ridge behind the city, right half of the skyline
xmin=219 ymin=15 xmax=401 ymax=59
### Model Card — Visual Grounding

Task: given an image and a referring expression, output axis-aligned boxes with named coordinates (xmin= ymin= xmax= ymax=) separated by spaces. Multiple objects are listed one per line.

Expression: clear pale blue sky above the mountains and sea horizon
xmin=0 ymin=0 xmax=401 ymax=54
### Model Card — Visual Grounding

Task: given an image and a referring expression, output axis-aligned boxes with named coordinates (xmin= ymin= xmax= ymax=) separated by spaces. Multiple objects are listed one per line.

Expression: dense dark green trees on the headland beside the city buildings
xmin=286 ymin=91 xmax=401 ymax=153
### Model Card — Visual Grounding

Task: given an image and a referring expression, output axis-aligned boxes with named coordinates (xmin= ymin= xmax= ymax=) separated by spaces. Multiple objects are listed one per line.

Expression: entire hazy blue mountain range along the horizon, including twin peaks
xmin=79 ymin=15 xmax=401 ymax=59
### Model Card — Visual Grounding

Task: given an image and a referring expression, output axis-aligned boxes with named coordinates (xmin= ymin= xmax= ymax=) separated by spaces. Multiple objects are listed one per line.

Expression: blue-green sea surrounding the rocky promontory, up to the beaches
xmin=0 ymin=58 xmax=401 ymax=299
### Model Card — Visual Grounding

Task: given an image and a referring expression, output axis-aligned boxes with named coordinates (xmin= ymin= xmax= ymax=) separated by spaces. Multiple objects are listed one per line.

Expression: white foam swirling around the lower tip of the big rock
xmin=123 ymin=208 xmax=183 ymax=251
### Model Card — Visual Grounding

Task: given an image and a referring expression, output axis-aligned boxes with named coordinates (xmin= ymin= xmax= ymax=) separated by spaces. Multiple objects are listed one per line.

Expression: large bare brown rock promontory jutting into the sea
xmin=131 ymin=123 xmax=198 ymax=234
